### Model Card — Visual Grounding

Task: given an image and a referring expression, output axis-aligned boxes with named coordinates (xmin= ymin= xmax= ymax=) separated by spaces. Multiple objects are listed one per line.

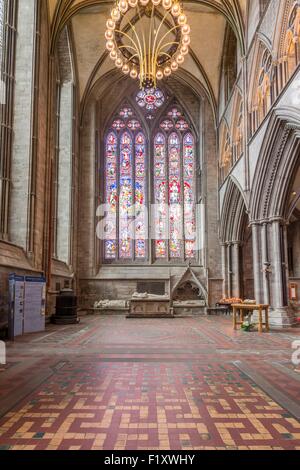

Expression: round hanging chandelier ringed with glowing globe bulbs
xmin=105 ymin=0 xmax=191 ymax=89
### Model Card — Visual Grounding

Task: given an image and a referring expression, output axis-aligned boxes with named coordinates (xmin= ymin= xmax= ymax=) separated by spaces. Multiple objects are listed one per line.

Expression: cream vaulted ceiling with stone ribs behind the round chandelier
xmin=48 ymin=0 xmax=247 ymax=108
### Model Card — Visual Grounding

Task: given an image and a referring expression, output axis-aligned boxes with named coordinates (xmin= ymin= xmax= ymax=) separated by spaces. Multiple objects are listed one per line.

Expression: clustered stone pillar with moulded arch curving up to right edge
xmin=250 ymin=107 xmax=300 ymax=327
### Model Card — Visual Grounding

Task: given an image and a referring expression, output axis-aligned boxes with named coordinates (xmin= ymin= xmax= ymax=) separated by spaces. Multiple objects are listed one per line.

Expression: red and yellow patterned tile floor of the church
xmin=0 ymin=316 xmax=300 ymax=450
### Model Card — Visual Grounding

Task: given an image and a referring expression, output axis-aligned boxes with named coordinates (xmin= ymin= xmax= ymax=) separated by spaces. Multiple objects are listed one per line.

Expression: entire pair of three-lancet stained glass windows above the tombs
xmin=104 ymin=105 xmax=197 ymax=262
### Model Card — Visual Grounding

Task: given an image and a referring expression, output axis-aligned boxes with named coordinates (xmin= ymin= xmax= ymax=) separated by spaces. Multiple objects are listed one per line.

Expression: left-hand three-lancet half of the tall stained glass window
xmin=104 ymin=106 xmax=148 ymax=261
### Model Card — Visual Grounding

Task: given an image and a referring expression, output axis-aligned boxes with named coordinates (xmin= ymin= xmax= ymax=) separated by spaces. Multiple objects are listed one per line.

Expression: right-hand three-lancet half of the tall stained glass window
xmin=154 ymin=107 xmax=197 ymax=260
